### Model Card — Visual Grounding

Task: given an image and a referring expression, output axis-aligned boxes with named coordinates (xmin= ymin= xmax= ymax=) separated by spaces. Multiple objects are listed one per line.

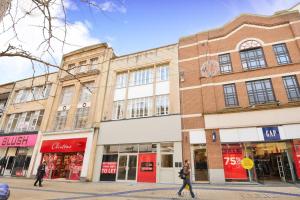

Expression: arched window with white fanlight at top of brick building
xmin=239 ymin=40 xmax=266 ymax=70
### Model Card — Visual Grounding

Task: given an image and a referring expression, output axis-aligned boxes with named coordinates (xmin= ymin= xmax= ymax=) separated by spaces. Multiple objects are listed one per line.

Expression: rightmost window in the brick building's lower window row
xmin=282 ymin=75 xmax=300 ymax=101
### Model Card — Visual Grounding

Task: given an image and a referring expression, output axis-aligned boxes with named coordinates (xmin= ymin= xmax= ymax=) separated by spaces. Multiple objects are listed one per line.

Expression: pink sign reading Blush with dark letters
xmin=0 ymin=134 xmax=37 ymax=147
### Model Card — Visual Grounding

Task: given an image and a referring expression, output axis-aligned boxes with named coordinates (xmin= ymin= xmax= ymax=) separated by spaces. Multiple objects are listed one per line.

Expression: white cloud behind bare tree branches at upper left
xmin=0 ymin=0 xmax=100 ymax=84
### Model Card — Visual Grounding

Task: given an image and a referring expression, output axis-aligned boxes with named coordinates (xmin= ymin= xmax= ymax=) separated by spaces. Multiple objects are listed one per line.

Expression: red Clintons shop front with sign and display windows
xmin=40 ymin=138 xmax=87 ymax=180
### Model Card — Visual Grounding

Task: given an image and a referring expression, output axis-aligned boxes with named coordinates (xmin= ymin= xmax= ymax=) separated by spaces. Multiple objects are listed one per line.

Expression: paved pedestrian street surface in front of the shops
xmin=0 ymin=177 xmax=300 ymax=200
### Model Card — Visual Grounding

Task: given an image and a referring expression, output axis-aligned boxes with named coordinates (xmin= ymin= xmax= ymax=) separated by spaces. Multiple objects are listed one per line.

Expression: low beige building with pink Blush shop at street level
xmin=0 ymin=73 xmax=57 ymax=176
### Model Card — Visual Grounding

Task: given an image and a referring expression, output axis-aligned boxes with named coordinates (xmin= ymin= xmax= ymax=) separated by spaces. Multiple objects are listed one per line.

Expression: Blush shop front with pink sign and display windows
xmin=0 ymin=133 xmax=37 ymax=176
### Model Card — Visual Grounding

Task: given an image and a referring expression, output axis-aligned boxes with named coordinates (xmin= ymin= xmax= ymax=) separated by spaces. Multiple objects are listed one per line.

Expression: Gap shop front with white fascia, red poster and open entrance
xmin=221 ymin=126 xmax=300 ymax=183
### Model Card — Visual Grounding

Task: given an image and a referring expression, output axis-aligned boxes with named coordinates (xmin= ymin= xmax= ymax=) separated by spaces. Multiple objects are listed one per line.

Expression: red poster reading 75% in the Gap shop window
xmin=222 ymin=145 xmax=248 ymax=180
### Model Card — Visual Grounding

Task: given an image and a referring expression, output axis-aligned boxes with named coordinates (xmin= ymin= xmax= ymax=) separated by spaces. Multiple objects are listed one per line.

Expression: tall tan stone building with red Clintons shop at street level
xmin=32 ymin=44 xmax=114 ymax=180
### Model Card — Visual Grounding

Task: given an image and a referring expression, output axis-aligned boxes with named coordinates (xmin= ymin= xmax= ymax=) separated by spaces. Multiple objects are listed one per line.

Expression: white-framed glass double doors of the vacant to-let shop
xmin=117 ymin=154 xmax=137 ymax=181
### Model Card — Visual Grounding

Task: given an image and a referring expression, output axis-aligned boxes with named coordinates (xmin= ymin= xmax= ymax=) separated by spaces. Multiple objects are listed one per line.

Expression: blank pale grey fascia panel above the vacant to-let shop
xmin=98 ymin=115 xmax=181 ymax=145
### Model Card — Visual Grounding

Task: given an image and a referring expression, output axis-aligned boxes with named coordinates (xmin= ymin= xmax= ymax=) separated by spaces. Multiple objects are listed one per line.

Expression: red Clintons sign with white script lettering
xmin=41 ymin=138 xmax=86 ymax=153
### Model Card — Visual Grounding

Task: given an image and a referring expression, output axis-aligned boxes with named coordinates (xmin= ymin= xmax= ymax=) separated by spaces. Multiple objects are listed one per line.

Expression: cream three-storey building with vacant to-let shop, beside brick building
xmin=93 ymin=44 xmax=182 ymax=182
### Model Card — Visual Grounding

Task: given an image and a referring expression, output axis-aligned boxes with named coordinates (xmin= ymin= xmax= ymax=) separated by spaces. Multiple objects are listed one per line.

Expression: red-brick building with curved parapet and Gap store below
xmin=179 ymin=11 xmax=300 ymax=182
